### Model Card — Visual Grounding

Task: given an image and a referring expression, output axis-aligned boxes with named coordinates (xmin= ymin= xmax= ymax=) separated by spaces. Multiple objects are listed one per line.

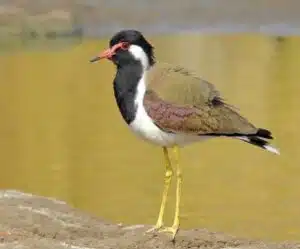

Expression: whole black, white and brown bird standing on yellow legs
xmin=90 ymin=29 xmax=279 ymax=240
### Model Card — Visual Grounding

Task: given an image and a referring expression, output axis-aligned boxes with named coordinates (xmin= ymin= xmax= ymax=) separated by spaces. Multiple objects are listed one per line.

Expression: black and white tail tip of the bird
xmin=236 ymin=129 xmax=280 ymax=155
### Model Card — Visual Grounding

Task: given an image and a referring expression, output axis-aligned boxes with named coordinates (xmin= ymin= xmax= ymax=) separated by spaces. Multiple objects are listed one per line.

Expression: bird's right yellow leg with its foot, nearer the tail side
xmin=162 ymin=146 xmax=182 ymax=240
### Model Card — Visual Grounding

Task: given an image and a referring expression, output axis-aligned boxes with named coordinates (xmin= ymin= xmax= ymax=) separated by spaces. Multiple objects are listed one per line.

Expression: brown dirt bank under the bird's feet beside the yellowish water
xmin=0 ymin=190 xmax=300 ymax=249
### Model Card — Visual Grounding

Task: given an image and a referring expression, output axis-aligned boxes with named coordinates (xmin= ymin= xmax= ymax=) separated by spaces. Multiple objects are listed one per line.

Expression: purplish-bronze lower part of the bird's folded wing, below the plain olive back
xmin=144 ymin=91 xmax=257 ymax=135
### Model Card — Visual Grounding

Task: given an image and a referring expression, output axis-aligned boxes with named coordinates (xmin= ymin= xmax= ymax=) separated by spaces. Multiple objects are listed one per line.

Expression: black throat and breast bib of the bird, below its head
xmin=114 ymin=61 xmax=143 ymax=124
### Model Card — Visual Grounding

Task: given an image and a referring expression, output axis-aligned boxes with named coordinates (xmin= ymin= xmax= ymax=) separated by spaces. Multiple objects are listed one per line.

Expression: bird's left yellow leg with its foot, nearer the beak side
xmin=147 ymin=147 xmax=173 ymax=232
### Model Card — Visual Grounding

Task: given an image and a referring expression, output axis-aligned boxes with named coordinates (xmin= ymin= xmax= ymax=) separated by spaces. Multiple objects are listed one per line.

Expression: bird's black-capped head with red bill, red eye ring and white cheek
xmin=91 ymin=30 xmax=155 ymax=67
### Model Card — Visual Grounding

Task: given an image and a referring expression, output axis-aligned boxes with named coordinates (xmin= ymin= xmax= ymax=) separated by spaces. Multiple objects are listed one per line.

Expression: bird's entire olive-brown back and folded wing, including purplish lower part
xmin=144 ymin=64 xmax=257 ymax=135
